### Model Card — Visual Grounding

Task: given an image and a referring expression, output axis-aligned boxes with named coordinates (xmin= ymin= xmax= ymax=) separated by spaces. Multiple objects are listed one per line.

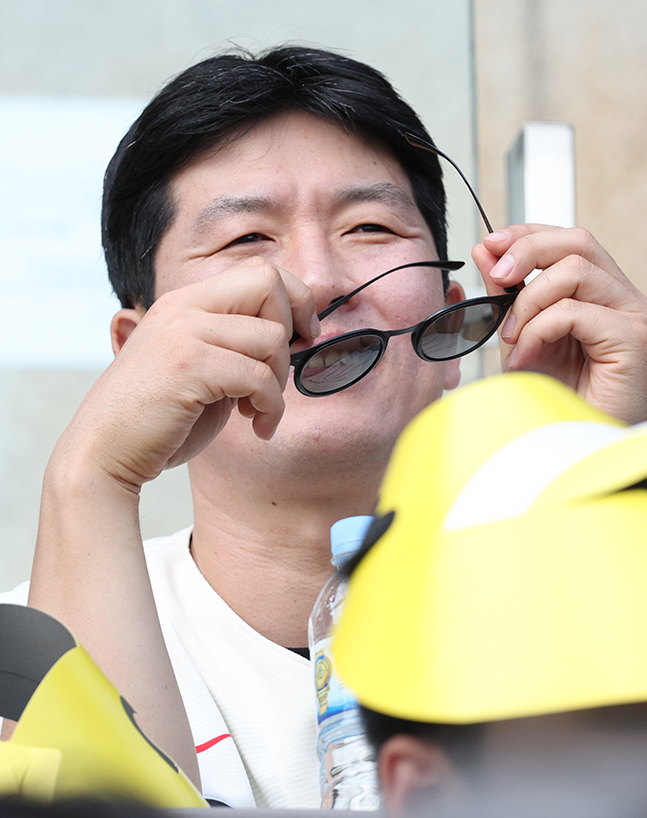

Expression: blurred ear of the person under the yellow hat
xmin=378 ymin=733 xmax=457 ymax=818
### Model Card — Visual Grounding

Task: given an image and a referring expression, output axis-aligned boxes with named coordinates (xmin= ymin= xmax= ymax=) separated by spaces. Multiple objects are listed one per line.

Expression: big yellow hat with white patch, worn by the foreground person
xmin=333 ymin=373 xmax=647 ymax=723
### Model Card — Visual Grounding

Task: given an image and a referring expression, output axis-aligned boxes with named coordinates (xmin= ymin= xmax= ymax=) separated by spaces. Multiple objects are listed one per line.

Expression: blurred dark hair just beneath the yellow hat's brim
xmin=360 ymin=705 xmax=487 ymax=777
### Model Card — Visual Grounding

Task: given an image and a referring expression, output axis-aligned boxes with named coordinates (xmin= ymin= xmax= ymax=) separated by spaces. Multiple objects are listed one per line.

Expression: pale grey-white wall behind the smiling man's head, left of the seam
xmin=0 ymin=0 xmax=481 ymax=590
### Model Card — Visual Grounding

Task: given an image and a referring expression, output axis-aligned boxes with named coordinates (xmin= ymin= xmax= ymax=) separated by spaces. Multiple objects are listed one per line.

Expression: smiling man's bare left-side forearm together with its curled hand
xmin=29 ymin=259 xmax=318 ymax=783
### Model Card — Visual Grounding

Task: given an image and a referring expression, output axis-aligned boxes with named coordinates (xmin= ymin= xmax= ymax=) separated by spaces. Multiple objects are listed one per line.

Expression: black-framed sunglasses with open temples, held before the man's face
xmin=290 ymin=133 xmax=519 ymax=397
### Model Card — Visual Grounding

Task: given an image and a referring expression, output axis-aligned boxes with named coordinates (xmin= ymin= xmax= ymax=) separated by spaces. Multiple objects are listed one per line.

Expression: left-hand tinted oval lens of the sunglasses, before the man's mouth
xmin=301 ymin=334 xmax=382 ymax=395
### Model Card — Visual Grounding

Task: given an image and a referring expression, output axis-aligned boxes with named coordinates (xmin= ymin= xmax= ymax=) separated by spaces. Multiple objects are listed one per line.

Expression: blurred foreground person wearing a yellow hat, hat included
xmin=333 ymin=373 xmax=647 ymax=817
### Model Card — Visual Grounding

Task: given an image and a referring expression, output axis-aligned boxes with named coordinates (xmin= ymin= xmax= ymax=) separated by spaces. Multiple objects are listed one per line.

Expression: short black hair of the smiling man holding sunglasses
xmin=101 ymin=46 xmax=447 ymax=308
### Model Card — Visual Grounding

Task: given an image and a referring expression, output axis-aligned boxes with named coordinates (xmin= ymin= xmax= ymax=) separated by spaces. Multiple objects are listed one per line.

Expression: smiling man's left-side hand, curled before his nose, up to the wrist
xmin=59 ymin=259 xmax=318 ymax=490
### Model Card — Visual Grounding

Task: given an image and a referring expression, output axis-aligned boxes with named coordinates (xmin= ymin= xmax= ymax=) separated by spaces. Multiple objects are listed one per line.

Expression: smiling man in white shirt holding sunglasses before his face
xmin=5 ymin=48 xmax=647 ymax=806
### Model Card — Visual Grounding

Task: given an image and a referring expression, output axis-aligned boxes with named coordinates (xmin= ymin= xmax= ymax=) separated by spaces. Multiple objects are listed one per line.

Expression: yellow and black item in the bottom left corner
xmin=0 ymin=605 xmax=208 ymax=807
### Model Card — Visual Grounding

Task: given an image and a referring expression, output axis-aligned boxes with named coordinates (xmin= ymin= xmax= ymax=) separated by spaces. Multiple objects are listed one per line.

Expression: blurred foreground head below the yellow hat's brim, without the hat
xmin=362 ymin=702 xmax=647 ymax=818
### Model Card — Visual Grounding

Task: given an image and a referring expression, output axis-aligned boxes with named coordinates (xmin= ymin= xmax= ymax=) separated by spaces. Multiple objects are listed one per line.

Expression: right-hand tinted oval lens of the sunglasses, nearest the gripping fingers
xmin=418 ymin=303 xmax=503 ymax=361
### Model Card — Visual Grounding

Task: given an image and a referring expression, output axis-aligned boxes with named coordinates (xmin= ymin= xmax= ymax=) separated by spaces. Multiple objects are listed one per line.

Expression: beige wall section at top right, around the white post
xmin=474 ymin=0 xmax=647 ymax=300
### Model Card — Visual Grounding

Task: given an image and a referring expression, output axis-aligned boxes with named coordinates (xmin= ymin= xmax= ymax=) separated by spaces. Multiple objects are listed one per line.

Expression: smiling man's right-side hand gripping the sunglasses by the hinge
xmin=473 ymin=224 xmax=647 ymax=423
